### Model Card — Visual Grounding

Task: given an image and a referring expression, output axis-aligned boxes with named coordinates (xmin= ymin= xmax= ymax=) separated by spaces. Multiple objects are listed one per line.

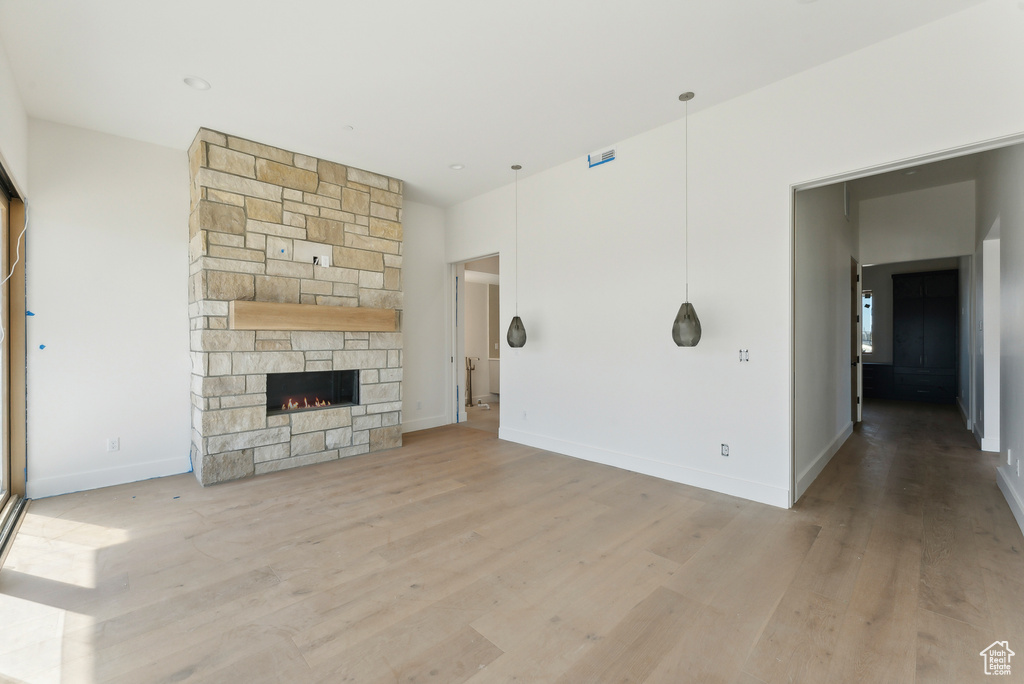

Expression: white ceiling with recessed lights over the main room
xmin=0 ymin=0 xmax=982 ymax=206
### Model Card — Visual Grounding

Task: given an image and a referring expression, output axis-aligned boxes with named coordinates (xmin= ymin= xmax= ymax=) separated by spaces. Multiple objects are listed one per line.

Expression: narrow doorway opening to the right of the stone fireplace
xmin=454 ymin=255 xmax=503 ymax=435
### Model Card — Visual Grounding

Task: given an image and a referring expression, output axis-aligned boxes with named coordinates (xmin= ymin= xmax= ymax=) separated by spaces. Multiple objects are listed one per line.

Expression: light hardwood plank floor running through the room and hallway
xmin=0 ymin=402 xmax=1024 ymax=684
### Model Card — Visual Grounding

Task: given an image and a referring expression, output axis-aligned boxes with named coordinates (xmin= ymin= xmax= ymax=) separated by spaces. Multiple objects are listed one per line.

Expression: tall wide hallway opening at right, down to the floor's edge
xmin=791 ymin=136 xmax=1022 ymax=503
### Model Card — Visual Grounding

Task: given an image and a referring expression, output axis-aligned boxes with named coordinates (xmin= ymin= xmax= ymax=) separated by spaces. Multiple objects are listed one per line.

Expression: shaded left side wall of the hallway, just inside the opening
xmin=794 ymin=183 xmax=857 ymax=499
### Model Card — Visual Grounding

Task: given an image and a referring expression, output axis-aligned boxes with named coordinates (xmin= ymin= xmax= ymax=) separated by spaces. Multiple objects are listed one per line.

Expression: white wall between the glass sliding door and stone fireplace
xmin=26 ymin=120 xmax=190 ymax=498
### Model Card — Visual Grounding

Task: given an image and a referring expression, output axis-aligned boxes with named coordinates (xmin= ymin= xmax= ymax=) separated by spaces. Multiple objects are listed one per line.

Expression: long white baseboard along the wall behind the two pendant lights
xmin=498 ymin=428 xmax=790 ymax=508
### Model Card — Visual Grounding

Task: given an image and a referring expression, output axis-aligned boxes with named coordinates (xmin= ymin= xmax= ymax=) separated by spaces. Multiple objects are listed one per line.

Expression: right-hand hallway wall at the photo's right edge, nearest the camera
xmin=978 ymin=140 xmax=1024 ymax=529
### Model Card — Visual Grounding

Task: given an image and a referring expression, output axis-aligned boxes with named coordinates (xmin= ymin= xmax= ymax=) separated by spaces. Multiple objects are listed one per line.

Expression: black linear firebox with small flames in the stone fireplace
xmin=266 ymin=371 xmax=359 ymax=416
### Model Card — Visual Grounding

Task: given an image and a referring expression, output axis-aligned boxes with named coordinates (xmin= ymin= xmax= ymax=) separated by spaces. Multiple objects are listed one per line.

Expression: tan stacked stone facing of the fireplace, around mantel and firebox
xmin=188 ymin=129 xmax=402 ymax=484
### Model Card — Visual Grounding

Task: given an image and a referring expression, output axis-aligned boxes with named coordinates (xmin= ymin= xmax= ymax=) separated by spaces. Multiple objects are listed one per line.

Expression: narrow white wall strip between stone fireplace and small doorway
xmin=401 ymin=201 xmax=451 ymax=432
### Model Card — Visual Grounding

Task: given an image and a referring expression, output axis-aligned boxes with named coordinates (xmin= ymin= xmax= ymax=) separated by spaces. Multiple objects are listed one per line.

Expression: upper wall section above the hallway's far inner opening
xmin=859 ymin=180 xmax=975 ymax=264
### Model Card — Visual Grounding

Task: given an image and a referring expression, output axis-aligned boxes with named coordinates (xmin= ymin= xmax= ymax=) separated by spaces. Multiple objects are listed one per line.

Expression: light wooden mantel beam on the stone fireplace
xmin=227 ymin=299 xmax=398 ymax=333
